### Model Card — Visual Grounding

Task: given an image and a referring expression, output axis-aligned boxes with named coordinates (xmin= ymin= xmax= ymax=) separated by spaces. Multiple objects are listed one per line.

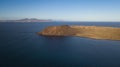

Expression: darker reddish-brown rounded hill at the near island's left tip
xmin=38 ymin=25 xmax=75 ymax=36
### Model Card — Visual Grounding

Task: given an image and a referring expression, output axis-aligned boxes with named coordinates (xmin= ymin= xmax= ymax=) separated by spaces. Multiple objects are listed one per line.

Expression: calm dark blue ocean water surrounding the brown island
xmin=0 ymin=22 xmax=120 ymax=67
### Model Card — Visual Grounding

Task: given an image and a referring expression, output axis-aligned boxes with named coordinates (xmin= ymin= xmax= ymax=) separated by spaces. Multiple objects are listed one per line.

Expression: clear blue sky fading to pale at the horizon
xmin=0 ymin=0 xmax=120 ymax=21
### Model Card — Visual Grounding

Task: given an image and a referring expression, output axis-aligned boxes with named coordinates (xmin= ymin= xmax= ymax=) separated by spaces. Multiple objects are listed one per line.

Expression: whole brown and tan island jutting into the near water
xmin=38 ymin=25 xmax=120 ymax=40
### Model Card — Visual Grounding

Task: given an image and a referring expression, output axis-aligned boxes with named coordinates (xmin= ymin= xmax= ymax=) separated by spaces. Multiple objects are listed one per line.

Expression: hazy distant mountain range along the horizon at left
xmin=0 ymin=18 xmax=53 ymax=22
